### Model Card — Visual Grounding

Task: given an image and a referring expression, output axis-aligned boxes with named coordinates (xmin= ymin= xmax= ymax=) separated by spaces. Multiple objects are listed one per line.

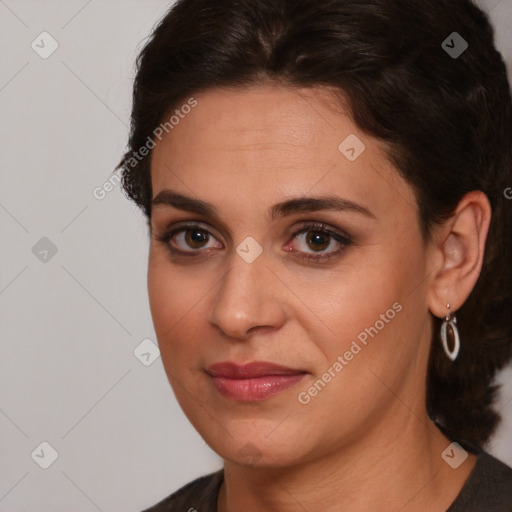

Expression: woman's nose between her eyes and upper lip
xmin=209 ymin=248 xmax=286 ymax=340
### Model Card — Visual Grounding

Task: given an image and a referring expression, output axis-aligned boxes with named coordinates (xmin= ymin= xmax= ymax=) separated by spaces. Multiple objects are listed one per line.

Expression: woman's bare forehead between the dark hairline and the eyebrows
xmin=151 ymin=86 xmax=415 ymax=218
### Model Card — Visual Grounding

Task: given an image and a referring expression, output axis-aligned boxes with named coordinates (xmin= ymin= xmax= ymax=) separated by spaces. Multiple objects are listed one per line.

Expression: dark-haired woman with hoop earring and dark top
xmin=120 ymin=0 xmax=512 ymax=512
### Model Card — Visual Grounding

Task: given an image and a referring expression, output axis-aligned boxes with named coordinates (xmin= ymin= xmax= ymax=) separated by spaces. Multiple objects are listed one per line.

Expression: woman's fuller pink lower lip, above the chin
xmin=212 ymin=373 xmax=306 ymax=402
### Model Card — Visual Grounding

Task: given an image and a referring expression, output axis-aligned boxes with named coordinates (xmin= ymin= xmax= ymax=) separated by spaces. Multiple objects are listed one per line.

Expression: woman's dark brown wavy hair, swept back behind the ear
xmin=117 ymin=0 xmax=512 ymax=447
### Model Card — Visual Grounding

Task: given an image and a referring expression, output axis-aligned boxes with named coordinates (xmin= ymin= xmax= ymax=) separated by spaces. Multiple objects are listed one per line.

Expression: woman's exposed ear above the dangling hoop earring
xmin=427 ymin=191 xmax=492 ymax=318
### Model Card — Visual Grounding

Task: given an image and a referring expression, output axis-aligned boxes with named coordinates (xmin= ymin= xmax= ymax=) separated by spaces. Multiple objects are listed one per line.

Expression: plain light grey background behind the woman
xmin=0 ymin=0 xmax=512 ymax=512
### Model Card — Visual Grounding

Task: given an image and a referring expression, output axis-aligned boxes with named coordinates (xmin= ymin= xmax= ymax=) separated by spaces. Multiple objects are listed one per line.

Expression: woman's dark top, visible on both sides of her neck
xmin=143 ymin=451 xmax=512 ymax=512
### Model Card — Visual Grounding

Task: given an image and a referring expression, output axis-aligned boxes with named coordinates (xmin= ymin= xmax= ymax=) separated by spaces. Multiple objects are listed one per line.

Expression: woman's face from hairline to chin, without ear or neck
xmin=148 ymin=86 xmax=440 ymax=467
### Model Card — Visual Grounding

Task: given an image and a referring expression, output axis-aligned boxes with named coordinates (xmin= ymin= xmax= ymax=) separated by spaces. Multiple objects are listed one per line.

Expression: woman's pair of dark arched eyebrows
xmin=151 ymin=189 xmax=377 ymax=221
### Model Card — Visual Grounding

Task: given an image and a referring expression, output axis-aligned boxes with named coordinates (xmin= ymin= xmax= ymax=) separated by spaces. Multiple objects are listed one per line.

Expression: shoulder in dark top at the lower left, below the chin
xmin=142 ymin=469 xmax=224 ymax=512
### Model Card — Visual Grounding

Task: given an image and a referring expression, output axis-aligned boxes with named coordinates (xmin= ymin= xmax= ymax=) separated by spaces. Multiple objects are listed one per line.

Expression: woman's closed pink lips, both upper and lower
xmin=207 ymin=361 xmax=307 ymax=402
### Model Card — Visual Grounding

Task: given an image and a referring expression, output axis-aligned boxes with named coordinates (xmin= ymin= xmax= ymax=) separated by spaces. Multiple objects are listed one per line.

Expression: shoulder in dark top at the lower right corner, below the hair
xmin=447 ymin=451 xmax=512 ymax=512
